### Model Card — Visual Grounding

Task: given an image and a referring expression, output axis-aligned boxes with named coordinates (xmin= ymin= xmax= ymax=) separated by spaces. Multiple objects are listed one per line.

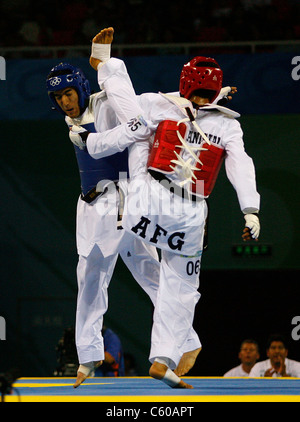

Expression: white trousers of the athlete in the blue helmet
xmin=76 ymin=233 xmax=159 ymax=364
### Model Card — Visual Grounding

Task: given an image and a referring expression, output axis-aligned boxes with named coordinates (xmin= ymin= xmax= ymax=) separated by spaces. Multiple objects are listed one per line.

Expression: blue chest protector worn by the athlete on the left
xmin=74 ymin=123 xmax=128 ymax=195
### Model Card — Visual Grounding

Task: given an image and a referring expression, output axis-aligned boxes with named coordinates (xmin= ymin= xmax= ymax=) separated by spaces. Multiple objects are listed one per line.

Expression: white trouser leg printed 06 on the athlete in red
xmin=149 ymin=251 xmax=201 ymax=369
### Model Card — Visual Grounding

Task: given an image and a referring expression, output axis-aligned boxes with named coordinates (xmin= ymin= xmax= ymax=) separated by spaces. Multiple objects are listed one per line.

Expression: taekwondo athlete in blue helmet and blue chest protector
xmin=46 ymin=63 xmax=159 ymax=388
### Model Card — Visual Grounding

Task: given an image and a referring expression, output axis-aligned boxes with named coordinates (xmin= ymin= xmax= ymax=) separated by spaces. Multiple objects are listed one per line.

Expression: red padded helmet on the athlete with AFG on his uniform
xmin=179 ymin=57 xmax=223 ymax=102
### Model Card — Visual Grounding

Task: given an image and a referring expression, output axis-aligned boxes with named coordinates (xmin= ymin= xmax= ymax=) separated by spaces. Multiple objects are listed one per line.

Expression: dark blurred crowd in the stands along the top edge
xmin=0 ymin=0 xmax=300 ymax=54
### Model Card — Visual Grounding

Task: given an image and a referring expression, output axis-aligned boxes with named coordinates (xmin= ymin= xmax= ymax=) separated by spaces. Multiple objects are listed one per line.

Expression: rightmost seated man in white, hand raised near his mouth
xmin=249 ymin=334 xmax=300 ymax=378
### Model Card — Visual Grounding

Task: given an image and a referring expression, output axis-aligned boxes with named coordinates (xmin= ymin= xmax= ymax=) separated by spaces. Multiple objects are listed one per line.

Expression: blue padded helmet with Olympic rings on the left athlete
xmin=46 ymin=63 xmax=91 ymax=115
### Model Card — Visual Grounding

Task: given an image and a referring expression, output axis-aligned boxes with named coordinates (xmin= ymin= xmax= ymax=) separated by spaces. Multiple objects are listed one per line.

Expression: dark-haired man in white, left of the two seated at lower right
xmin=224 ymin=339 xmax=260 ymax=377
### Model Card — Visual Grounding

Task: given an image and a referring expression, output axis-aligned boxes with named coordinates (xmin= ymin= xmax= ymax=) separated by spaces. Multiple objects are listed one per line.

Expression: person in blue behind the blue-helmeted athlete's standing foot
xmin=95 ymin=326 xmax=125 ymax=377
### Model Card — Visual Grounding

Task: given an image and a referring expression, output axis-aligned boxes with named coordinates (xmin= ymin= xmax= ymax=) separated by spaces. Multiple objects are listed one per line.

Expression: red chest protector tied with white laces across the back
xmin=148 ymin=120 xmax=225 ymax=197
